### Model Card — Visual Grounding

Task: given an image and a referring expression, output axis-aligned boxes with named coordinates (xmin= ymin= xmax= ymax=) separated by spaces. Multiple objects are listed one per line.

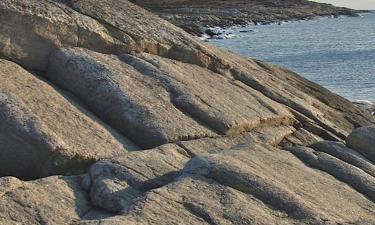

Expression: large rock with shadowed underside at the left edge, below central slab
xmin=0 ymin=60 xmax=137 ymax=179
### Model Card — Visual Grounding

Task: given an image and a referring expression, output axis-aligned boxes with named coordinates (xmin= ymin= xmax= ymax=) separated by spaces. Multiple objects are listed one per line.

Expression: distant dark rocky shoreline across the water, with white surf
xmin=131 ymin=0 xmax=368 ymax=37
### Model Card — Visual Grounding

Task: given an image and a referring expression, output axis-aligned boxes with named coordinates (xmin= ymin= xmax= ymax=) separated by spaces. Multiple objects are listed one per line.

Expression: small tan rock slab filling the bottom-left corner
xmin=0 ymin=177 xmax=91 ymax=225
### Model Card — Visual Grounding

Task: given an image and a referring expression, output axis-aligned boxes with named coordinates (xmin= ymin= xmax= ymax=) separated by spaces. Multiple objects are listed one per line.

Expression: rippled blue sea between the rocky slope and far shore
xmin=210 ymin=13 xmax=375 ymax=102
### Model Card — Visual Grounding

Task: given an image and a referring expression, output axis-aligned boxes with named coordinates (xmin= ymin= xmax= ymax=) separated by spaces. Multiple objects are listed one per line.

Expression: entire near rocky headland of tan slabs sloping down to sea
xmin=0 ymin=0 xmax=375 ymax=225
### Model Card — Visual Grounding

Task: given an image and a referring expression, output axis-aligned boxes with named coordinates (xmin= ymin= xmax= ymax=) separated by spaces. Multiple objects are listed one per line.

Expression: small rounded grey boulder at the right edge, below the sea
xmin=346 ymin=126 xmax=375 ymax=163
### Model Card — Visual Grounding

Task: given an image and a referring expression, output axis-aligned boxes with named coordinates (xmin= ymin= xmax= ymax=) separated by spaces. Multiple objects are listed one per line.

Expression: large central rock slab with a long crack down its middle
xmin=47 ymin=49 xmax=293 ymax=147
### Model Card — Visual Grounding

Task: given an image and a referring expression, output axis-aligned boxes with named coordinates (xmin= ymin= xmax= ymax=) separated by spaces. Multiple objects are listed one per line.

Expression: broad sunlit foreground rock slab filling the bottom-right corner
xmin=78 ymin=143 xmax=374 ymax=224
